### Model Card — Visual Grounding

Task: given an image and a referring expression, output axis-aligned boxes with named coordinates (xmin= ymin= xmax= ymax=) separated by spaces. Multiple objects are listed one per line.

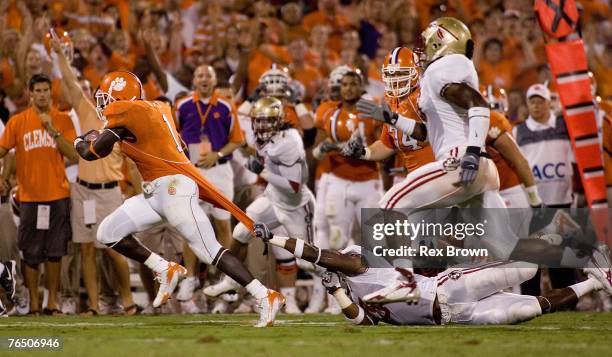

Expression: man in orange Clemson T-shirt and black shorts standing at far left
xmin=0 ymin=75 xmax=77 ymax=315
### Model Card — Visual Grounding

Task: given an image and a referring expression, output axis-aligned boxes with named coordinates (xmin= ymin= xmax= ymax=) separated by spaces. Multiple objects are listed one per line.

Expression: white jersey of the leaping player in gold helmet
xmin=419 ymin=54 xmax=478 ymax=160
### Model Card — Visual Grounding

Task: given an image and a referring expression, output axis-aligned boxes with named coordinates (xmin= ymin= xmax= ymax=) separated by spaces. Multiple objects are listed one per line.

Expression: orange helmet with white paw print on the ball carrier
xmin=95 ymin=71 xmax=143 ymax=120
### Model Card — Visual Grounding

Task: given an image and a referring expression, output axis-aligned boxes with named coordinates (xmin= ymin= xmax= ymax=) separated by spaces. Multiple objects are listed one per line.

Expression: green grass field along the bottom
xmin=0 ymin=312 xmax=612 ymax=357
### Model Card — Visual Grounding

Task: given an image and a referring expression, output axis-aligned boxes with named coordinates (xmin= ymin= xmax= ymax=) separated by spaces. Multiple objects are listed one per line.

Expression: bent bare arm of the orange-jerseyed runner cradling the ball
xmin=74 ymin=128 xmax=125 ymax=161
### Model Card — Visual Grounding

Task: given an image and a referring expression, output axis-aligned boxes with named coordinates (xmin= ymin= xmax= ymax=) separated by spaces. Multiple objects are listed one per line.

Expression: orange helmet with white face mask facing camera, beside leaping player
xmin=382 ymin=47 xmax=419 ymax=98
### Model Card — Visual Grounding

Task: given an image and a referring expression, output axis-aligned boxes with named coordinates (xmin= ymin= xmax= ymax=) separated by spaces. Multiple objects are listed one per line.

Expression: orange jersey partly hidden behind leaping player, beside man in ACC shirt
xmin=486 ymin=111 xmax=521 ymax=191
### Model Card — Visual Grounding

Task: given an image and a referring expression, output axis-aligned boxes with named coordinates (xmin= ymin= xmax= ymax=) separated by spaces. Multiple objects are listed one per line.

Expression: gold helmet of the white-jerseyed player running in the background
xmin=251 ymin=97 xmax=285 ymax=144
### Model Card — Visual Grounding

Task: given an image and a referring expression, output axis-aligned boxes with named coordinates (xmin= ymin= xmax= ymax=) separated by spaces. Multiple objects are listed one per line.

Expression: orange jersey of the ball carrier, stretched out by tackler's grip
xmin=104 ymin=100 xmax=253 ymax=229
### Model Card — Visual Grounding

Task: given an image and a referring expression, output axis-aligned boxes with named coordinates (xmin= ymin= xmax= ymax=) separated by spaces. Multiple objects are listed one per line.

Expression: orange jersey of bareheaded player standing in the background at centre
xmin=315 ymin=104 xmax=380 ymax=181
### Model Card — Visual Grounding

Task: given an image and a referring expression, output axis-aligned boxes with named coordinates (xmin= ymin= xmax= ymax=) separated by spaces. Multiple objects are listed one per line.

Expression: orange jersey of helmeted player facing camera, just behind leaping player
xmin=380 ymin=90 xmax=435 ymax=172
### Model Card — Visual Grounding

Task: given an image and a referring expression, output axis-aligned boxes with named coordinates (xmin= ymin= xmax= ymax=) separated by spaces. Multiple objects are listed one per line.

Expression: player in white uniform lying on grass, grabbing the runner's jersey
xmin=254 ymin=223 xmax=612 ymax=325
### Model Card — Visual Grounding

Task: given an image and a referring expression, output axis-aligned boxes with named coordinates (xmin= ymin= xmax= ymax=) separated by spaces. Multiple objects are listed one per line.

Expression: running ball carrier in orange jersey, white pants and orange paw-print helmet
xmin=75 ymin=71 xmax=285 ymax=327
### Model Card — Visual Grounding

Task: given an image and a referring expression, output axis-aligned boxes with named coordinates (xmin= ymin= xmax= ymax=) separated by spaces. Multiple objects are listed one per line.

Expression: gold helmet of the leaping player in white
xmin=415 ymin=17 xmax=474 ymax=67
